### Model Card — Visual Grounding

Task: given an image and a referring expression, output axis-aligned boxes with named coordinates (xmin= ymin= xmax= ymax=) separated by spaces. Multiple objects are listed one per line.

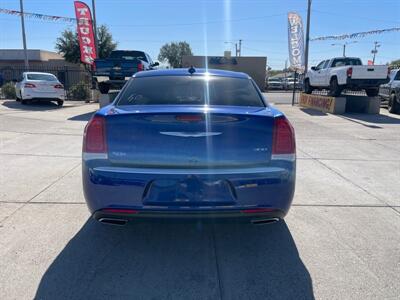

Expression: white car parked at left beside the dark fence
xmin=15 ymin=72 xmax=65 ymax=106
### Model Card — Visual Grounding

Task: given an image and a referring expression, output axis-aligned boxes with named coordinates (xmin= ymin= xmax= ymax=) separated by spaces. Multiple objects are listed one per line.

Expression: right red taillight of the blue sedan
xmin=272 ymin=117 xmax=296 ymax=160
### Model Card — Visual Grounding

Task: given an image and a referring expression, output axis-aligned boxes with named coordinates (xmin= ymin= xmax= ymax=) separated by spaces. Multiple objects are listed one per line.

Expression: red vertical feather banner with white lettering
xmin=74 ymin=1 xmax=97 ymax=65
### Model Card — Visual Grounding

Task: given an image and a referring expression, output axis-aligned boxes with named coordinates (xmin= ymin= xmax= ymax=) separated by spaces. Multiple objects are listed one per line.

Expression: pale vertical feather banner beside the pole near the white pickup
xmin=288 ymin=12 xmax=305 ymax=72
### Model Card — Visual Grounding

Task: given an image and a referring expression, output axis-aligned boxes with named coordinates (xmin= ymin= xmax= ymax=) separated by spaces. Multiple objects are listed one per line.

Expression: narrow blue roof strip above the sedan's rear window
xmin=134 ymin=68 xmax=249 ymax=79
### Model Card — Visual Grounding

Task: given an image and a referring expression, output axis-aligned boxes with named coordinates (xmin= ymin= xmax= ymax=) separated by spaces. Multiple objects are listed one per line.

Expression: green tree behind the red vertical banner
xmin=55 ymin=25 xmax=117 ymax=63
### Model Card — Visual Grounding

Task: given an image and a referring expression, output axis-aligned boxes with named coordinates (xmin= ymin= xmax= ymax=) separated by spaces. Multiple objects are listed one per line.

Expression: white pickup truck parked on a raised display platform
xmin=304 ymin=57 xmax=389 ymax=97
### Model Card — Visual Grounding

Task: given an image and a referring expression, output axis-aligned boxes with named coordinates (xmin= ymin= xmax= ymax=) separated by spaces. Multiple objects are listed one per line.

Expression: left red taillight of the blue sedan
xmin=83 ymin=116 xmax=107 ymax=153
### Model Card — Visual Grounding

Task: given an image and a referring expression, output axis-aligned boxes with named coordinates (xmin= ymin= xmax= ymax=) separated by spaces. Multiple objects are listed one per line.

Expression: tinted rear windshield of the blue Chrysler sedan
xmin=117 ymin=76 xmax=265 ymax=107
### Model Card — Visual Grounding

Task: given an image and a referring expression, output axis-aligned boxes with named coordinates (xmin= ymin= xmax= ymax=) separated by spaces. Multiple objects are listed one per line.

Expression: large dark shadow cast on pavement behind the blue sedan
xmin=35 ymin=219 xmax=314 ymax=299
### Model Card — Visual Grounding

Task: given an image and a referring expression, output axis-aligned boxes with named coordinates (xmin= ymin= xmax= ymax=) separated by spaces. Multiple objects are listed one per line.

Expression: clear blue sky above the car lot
xmin=0 ymin=0 xmax=400 ymax=69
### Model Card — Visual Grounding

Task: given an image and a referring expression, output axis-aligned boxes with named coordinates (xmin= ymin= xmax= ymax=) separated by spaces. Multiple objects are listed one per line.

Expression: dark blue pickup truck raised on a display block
xmin=93 ymin=50 xmax=158 ymax=94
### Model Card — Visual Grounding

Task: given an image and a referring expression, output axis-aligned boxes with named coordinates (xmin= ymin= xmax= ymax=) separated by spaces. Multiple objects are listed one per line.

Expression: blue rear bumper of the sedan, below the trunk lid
xmin=82 ymin=160 xmax=295 ymax=219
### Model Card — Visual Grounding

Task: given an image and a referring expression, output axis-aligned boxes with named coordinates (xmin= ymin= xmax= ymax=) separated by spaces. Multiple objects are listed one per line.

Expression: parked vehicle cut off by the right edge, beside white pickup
xmin=379 ymin=69 xmax=400 ymax=113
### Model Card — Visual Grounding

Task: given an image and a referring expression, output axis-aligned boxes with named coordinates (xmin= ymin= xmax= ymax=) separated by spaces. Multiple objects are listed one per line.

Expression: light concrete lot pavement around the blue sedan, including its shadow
xmin=0 ymin=98 xmax=400 ymax=300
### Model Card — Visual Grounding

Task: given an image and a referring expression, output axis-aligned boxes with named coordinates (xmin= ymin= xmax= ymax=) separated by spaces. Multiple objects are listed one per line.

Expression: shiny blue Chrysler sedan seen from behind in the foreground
xmin=82 ymin=68 xmax=296 ymax=225
